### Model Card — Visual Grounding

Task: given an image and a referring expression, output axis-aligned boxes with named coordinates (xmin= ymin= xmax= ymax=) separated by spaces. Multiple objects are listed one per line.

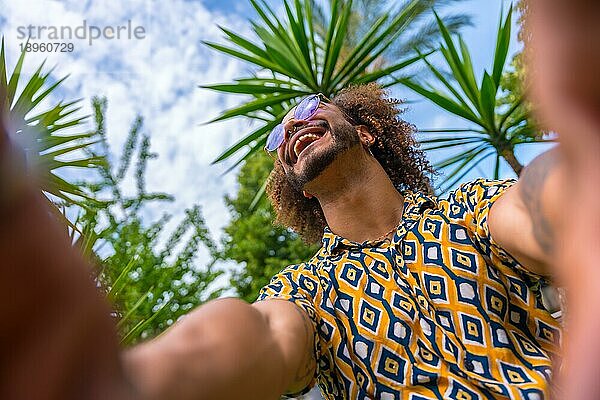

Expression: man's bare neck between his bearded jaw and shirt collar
xmin=309 ymin=147 xmax=404 ymax=242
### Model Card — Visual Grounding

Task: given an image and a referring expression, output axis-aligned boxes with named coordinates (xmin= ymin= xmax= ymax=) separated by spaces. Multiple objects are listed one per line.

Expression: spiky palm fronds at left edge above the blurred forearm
xmin=0 ymin=39 xmax=105 ymax=208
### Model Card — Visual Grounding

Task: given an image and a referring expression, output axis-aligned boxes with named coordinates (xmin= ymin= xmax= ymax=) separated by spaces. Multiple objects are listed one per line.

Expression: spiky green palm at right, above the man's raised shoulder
xmin=402 ymin=7 xmax=548 ymax=191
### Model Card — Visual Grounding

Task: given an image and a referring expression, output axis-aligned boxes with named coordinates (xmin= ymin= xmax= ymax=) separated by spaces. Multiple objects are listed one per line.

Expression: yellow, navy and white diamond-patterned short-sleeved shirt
xmin=258 ymin=179 xmax=561 ymax=400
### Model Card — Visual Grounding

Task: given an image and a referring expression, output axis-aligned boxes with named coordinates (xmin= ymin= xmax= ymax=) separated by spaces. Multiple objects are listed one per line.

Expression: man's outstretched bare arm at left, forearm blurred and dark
xmin=0 ymin=110 xmax=315 ymax=400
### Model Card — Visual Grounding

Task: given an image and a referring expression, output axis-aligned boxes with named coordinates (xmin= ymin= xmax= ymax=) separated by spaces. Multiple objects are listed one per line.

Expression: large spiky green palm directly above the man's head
xmin=201 ymin=0 xmax=468 ymax=166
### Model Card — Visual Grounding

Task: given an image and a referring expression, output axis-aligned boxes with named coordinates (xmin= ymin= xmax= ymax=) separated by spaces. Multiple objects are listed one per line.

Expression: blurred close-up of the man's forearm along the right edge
xmin=527 ymin=0 xmax=600 ymax=400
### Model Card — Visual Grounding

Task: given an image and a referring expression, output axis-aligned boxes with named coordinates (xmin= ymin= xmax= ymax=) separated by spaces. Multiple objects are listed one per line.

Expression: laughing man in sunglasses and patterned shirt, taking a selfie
xmin=0 ymin=80 xmax=561 ymax=399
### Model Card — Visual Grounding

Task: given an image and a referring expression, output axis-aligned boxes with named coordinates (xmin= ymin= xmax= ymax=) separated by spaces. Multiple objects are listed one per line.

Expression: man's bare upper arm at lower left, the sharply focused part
xmin=124 ymin=299 xmax=315 ymax=400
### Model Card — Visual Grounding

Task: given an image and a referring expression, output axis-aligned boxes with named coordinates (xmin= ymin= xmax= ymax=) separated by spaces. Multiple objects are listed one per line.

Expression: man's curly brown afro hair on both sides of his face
xmin=266 ymin=83 xmax=434 ymax=243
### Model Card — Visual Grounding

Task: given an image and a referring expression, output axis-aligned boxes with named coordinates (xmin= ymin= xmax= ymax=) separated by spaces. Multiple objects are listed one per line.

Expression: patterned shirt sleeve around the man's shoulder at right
xmin=448 ymin=179 xmax=539 ymax=278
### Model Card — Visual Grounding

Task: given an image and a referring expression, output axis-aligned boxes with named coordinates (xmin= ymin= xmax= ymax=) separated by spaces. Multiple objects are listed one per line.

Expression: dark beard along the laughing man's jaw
xmin=286 ymin=123 xmax=360 ymax=192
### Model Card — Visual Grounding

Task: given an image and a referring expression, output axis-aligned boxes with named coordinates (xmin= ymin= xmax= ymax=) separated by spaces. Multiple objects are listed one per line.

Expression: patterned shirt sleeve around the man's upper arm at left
xmin=256 ymin=264 xmax=321 ymax=396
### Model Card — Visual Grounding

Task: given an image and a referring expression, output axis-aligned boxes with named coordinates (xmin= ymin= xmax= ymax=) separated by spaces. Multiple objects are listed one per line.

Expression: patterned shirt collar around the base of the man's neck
xmin=322 ymin=190 xmax=437 ymax=255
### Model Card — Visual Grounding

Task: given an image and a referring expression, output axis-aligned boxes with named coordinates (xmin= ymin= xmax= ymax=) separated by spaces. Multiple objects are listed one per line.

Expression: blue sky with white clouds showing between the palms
xmin=0 ymin=0 xmax=542 ymax=290
